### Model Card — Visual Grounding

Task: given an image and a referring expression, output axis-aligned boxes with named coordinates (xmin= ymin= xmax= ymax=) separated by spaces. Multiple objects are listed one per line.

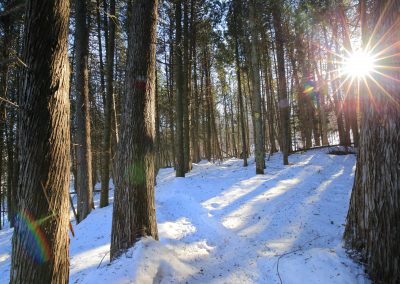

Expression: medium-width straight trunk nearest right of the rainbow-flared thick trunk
xmin=75 ymin=0 xmax=93 ymax=222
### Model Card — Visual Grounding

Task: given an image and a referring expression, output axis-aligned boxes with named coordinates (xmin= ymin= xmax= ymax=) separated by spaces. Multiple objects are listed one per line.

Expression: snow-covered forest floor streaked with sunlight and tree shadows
xmin=0 ymin=150 xmax=370 ymax=284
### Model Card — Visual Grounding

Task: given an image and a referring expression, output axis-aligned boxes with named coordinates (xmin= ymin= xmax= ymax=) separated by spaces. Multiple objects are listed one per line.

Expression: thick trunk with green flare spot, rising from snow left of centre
xmin=110 ymin=0 xmax=158 ymax=259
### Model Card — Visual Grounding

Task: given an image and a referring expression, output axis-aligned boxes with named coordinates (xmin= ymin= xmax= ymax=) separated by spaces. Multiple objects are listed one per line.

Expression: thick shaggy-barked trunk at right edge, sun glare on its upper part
xmin=344 ymin=0 xmax=400 ymax=283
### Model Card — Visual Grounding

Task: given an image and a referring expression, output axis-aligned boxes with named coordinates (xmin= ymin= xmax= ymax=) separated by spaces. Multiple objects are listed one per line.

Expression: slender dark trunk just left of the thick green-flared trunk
xmin=100 ymin=0 xmax=116 ymax=207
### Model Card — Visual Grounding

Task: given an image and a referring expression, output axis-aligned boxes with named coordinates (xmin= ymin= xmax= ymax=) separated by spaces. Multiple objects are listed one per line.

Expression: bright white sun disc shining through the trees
xmin=342 ymin=50 xmax=376 ymax=79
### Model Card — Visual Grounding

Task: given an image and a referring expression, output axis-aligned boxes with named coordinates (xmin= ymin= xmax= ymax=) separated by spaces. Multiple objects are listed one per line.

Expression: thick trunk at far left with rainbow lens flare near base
xmin=10 ymin=0 xmax=70 ymax=283
